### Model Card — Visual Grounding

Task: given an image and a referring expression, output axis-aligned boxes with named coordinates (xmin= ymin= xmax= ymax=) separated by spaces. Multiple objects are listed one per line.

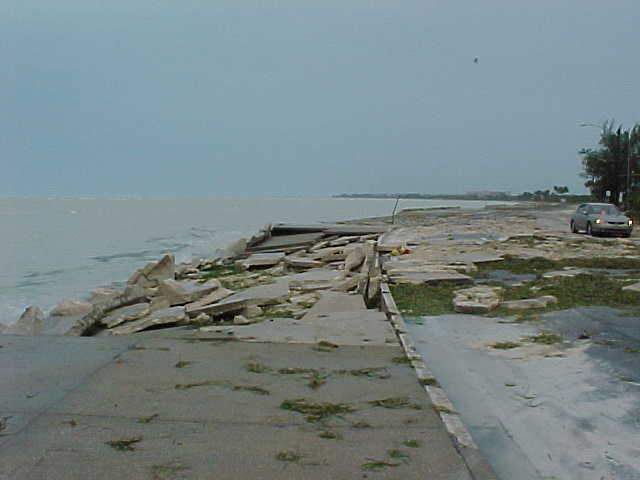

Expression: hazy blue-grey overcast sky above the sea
xmin=0 ymin=0 xmax=640 ymax=196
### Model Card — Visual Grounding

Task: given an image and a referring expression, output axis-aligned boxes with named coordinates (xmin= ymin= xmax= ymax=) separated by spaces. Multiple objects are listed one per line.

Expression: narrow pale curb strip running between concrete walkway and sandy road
xmin=380 ymin=282 xmax=497 ymax=480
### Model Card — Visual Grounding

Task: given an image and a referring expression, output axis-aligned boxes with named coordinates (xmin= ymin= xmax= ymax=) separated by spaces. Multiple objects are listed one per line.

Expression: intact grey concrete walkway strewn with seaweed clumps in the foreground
xmin=0 ymin=294 xmax=486 ymax=480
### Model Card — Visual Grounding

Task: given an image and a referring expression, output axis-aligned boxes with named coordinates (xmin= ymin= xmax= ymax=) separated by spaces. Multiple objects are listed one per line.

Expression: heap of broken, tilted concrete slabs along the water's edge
xmin=16 ymin=226 xmax=380 ymax=336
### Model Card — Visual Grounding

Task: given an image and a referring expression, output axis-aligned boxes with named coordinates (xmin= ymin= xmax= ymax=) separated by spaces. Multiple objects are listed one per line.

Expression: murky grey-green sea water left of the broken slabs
xmin=0 ymin=198 xmax=508 ymax=325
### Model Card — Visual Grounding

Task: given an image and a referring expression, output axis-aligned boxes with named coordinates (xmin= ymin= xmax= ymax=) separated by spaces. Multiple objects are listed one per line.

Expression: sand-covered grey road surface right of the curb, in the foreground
xmin=408 ymin=307 xmax=640 ymax=480
